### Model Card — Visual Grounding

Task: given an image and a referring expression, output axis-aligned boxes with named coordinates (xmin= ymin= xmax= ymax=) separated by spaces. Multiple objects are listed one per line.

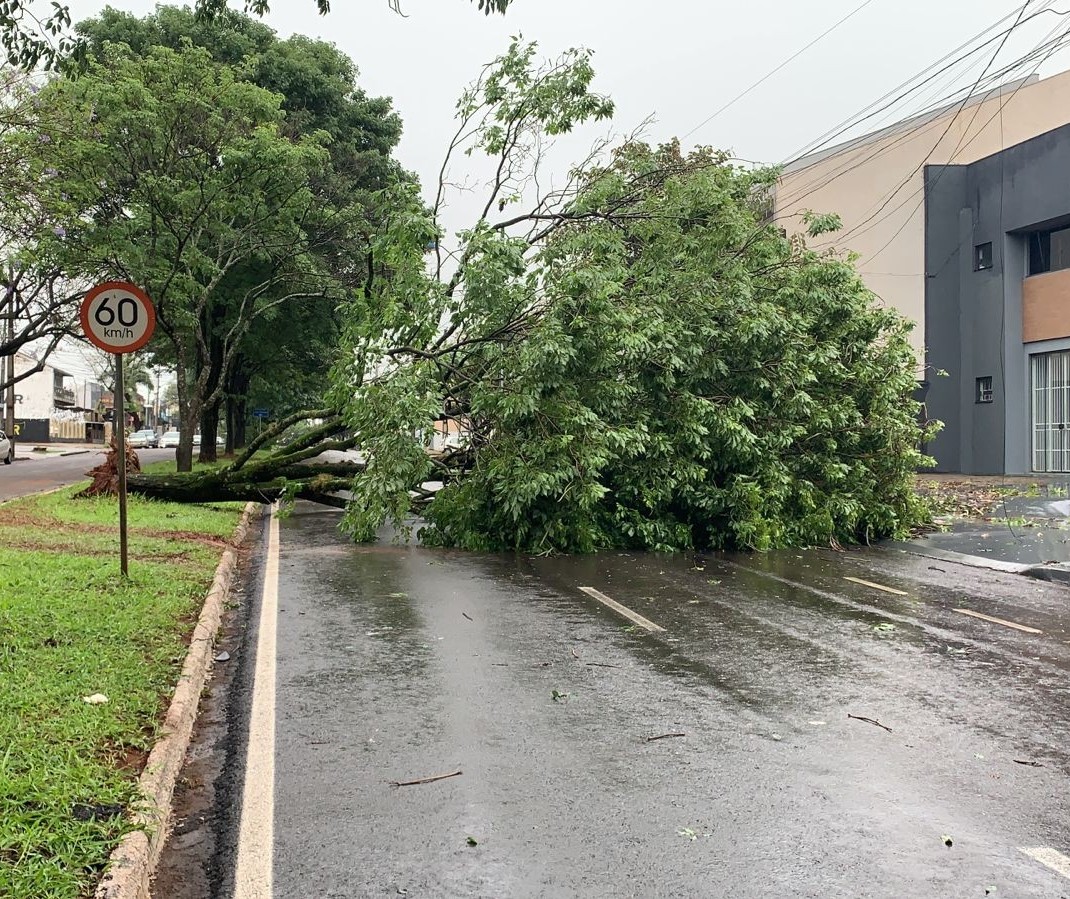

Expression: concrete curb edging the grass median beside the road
xmin=94 ymin=503 xmax=259 ymax=899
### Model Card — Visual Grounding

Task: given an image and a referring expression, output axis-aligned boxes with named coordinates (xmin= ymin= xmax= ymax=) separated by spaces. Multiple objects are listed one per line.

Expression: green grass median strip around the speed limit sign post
xmin=0 ymin=487 xmax=241 ymax=899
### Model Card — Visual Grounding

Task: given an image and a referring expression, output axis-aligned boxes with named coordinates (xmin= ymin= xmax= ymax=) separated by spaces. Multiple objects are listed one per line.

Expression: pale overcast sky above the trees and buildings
xmin=52 ymin=0 xmax=1070 ymax=378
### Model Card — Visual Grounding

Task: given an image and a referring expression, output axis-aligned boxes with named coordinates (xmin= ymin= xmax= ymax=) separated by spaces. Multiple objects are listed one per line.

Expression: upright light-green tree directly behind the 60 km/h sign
xmin=21 ymin=45 xmax=338 ymax=471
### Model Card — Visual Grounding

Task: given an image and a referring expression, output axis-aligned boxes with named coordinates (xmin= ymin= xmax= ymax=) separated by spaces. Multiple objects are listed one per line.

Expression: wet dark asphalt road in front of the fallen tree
xmin=219 ymin=504 xmax=1070 ymax=899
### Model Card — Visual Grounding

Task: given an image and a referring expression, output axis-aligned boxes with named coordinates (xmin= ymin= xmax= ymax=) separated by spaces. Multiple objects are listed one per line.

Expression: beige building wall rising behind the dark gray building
xmin=776 ymin=72 xmax=1070 ymax=361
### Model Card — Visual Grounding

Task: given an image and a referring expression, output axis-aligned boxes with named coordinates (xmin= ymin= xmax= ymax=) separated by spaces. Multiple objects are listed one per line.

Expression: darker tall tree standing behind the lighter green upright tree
xmin=78 ymin=7 xmax=403 ymax=461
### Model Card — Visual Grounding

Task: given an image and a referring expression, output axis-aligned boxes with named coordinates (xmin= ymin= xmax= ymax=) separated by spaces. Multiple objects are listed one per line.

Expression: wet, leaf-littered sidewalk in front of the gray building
xmin=893 ymin=475 xmax=1070 ymax=583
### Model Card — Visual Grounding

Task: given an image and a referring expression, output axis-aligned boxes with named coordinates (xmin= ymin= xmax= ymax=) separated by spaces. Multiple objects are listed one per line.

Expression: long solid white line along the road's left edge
xmin=234 ymin=509 xmax=278 ymax=899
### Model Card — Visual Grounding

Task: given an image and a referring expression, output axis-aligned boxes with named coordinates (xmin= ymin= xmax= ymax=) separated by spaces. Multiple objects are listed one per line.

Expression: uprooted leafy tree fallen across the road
xmin=127 ymin=42 xmax=926 ymax=552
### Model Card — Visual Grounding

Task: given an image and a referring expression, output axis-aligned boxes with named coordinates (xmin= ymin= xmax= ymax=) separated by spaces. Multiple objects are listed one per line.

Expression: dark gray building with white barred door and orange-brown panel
xmin=924 ymin=125 xmax=1070 ymax=474
